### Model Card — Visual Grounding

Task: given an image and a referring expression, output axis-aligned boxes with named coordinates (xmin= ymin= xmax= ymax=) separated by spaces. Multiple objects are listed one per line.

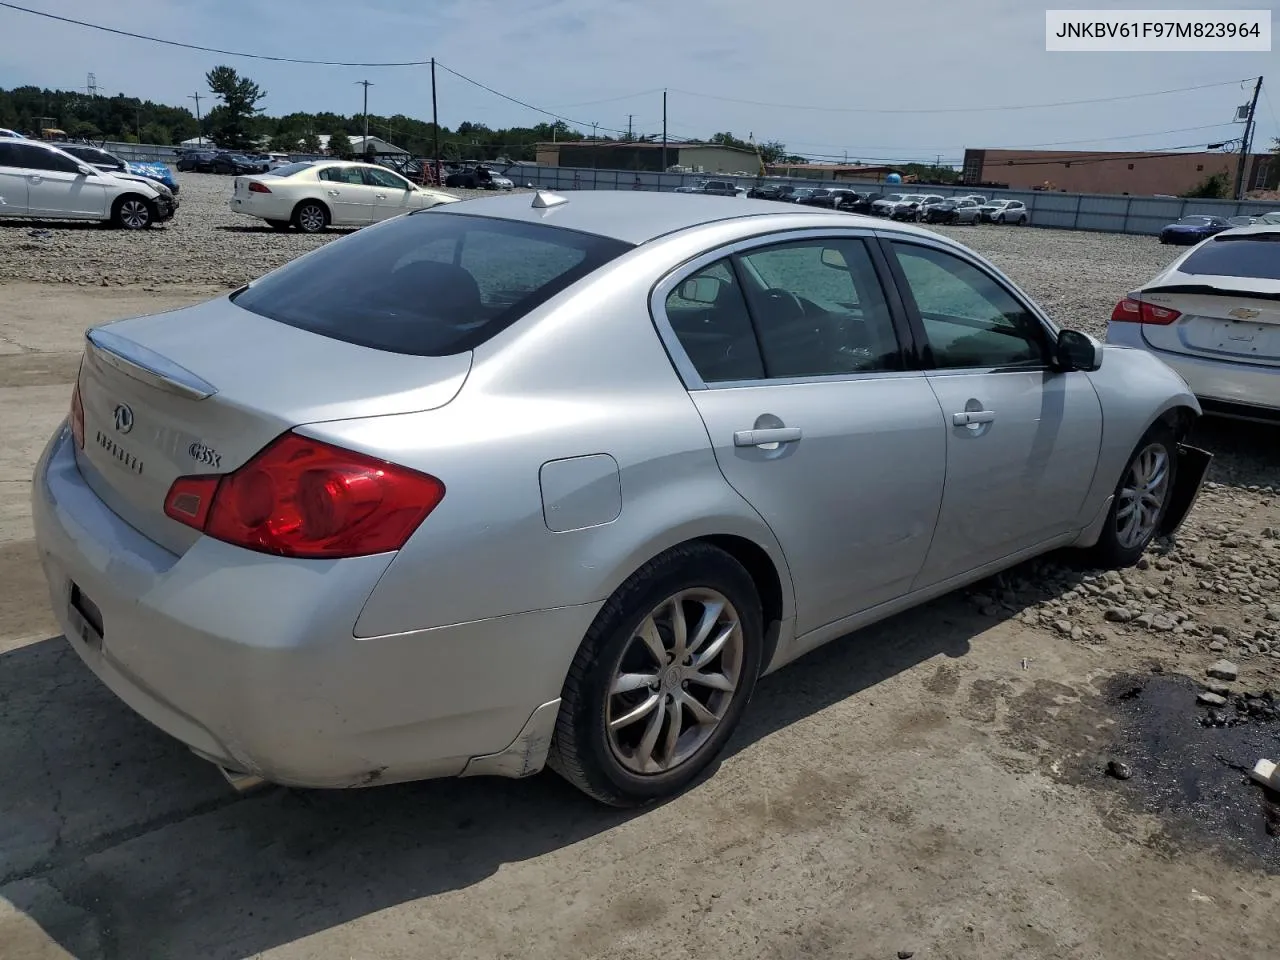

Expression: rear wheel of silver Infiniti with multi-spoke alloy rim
xmin=547 ymin=543 xmax=764 ymax=806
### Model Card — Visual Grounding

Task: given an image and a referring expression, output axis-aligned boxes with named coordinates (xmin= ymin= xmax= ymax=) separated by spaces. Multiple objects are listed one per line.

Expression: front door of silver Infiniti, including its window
xmin=884 ymin=238 xmax=1102 ymax=588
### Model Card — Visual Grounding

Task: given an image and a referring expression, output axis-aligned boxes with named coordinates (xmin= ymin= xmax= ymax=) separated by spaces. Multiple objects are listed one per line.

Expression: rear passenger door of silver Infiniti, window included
xmin=654 ymin=232 xmax=946 ymax=635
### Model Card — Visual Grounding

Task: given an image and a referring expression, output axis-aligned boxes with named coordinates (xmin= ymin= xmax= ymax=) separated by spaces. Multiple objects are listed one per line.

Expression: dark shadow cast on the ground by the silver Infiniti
xmin=0 ymin=595 xmax=977 ymax=960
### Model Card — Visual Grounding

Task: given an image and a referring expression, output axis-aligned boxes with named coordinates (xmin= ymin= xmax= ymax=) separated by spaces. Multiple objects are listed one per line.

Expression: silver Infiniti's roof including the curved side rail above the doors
xmin=424 ymin=189 xmax=963 ymax=247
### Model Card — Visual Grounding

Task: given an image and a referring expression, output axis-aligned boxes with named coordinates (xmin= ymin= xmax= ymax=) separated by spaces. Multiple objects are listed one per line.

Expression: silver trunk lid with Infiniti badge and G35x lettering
xmin=76 ymin=298 xmax=471 ymax=554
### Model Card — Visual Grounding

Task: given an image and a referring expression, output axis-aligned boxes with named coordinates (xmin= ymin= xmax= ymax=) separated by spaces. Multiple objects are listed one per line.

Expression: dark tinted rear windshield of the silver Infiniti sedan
xmin=232 ymin=211 xmax=632 ymax=357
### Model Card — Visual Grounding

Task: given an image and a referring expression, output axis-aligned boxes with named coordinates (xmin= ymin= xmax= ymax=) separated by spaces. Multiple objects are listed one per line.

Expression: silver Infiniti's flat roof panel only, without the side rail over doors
xmin=431 ymin=189 xmax=860 ymax=244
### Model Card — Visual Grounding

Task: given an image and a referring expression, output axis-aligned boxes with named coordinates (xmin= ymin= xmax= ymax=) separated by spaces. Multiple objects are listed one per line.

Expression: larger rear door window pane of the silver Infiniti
xmin=740 ymin=239 xmax=901 ymax=378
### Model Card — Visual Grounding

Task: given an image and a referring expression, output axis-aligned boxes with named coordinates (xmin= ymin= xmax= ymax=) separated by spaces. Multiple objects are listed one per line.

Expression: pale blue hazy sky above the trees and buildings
xmin=0 ymin=0 xmax=1280 ymax=161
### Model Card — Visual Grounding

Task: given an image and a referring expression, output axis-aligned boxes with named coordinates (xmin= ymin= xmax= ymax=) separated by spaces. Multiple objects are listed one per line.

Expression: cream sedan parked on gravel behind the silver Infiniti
xmin=228 ymin=160 xmax=457 ymax=233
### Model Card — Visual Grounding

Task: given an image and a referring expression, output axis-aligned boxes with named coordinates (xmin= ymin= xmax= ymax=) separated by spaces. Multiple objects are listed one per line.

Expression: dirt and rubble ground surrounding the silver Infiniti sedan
xmin=0 ymin=284 xmax=1280 ymax=960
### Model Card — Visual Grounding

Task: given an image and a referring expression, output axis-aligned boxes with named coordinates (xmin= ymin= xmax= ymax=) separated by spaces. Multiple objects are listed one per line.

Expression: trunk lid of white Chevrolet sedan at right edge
xmin=1138 ymin=277 xmax=1280 ymax=366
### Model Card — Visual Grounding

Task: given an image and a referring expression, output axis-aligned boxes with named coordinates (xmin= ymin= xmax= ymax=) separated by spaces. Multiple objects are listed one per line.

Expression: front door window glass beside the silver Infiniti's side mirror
xmin=892 ymin=241 xmax=1048 ymax=367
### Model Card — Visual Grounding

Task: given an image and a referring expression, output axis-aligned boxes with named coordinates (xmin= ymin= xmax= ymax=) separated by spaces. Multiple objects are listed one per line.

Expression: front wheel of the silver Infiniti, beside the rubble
xmin=1093 ymin=422 xmax=1178 ymax=570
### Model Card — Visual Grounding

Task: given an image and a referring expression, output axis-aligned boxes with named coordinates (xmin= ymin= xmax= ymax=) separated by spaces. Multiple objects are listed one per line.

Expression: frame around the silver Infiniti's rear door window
xmin=649 ymin=227 xmax=920 ymax=390
